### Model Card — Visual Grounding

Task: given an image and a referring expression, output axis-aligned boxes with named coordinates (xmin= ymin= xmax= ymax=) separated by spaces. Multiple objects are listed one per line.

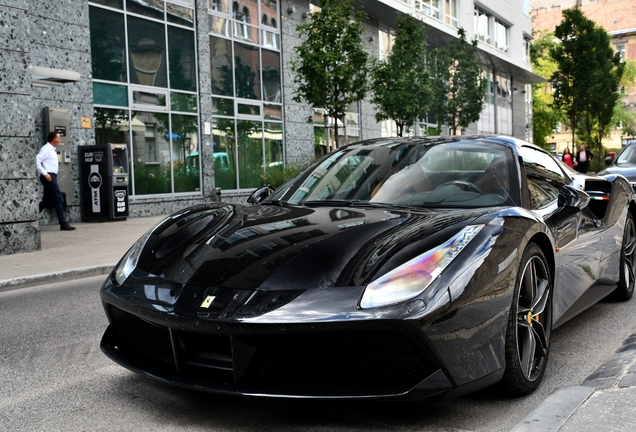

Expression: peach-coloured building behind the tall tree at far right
xmin=531 ymin=0 xmax=636 ymax=154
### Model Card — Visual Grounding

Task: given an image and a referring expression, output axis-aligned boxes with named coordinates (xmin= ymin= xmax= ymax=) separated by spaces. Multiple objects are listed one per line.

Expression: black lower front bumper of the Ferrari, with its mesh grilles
xmin=101 ymin=305 xmax=453 ymax=399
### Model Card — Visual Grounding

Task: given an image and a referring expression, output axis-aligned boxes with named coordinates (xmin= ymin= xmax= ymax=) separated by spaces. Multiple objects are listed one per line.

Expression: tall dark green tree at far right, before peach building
xmin=550 ymin=7 xmax=624 ymax=155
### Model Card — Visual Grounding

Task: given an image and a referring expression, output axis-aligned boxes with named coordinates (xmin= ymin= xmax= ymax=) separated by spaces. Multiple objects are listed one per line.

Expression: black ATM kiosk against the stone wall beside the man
xmin=79 ymin=143 xmax=129 ymax=221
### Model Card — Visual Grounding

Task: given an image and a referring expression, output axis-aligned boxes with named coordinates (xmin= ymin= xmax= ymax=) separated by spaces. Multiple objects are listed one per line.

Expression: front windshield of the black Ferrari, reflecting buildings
xmin=267 ymin=141 xmax=518 ymax=208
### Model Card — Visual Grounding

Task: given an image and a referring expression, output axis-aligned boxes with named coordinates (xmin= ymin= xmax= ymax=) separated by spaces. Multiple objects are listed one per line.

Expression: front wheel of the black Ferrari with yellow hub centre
xmin=501 ymin=243 xmax=552 ymax=396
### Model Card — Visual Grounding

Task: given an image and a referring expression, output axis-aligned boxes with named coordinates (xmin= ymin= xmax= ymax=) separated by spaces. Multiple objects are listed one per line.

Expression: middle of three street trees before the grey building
xmin=371 ymin=15 xmax=431 ymax=136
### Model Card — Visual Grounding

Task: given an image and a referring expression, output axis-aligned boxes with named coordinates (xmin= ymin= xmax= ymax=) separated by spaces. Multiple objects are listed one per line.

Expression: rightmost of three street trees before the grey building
xmin=431 ymin=28 xmax=486 ymax=135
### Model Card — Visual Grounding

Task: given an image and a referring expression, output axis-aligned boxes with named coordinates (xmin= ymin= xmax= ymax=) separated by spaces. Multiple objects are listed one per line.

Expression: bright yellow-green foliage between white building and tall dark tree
xmin=530 ymin=32 xmax=562 ymax=149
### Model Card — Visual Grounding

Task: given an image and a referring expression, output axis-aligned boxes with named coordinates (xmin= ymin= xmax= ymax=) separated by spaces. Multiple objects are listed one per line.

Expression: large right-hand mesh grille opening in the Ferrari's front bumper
xmin=246 ymin=332 xmax=427 ymax=391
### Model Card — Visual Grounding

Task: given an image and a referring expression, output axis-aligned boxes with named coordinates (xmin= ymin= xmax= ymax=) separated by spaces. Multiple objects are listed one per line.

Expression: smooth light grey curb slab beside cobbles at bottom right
xmin=510 ymin=386 xmax=595 ymax=432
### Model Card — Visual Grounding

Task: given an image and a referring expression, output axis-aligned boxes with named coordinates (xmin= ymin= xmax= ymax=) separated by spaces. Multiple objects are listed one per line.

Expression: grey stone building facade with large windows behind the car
xmin=0 ymin=0 xmax=541 ymax=254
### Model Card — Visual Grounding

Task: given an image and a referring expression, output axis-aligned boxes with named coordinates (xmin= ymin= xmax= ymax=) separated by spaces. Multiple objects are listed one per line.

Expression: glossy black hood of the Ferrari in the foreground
xmin=137 ymin=204 xmax=492 ymax=290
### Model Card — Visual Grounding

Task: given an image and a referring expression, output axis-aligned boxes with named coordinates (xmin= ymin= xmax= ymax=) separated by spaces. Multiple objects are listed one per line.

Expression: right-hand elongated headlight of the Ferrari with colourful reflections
xmin=360 ymin=225 xmax=484 ymax=309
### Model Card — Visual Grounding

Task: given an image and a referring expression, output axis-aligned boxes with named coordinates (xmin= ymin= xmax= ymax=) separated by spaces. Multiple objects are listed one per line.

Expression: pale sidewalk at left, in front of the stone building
xmin=0 ymin=216 xmax=165 ymax=291
